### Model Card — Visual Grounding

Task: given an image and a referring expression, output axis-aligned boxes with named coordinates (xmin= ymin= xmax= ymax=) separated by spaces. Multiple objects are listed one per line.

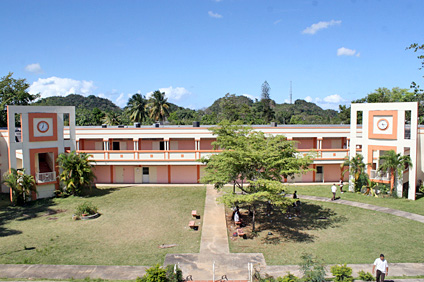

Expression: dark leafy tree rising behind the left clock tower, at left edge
xmin=0 ymin=72 xmax=39 ymax=127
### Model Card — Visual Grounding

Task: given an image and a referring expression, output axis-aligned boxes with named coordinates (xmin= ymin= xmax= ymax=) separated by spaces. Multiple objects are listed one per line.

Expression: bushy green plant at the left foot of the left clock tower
xmin=2 ymin=168 xmax=37 ymax=205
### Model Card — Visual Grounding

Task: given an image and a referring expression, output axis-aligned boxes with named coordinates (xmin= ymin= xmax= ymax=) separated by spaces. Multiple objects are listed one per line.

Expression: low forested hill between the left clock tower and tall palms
xmin=33 ymin=94 xmax=121 ymax=112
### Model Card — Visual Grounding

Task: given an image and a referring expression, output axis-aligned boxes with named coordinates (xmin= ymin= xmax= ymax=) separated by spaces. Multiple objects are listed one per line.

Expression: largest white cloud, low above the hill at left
xmin=28 ymin=76 xmax=96 ymax=98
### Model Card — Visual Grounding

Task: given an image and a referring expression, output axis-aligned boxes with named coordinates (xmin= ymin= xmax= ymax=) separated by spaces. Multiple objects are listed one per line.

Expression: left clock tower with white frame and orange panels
xmin=7 ymin=106 xmax=76 ymax=199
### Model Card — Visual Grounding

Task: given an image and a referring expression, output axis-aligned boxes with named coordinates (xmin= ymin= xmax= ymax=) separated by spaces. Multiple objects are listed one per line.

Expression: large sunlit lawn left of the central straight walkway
xmin=0 ymin=185 xmax=206 ymax=265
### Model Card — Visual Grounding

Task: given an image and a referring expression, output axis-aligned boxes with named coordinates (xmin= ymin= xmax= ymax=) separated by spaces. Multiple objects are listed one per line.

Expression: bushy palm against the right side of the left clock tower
xmin=57 ymin=151 xmax=96 ymax=195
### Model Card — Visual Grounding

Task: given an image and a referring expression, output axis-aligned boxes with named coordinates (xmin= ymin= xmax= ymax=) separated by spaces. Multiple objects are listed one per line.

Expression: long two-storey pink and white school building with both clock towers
xmin=0 ymin=102 xmax=424 ymax=199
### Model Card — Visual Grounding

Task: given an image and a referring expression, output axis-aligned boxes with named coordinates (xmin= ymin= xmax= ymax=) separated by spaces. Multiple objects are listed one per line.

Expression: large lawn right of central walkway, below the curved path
xmin=229 ymin=199 xmax=424 ymax=265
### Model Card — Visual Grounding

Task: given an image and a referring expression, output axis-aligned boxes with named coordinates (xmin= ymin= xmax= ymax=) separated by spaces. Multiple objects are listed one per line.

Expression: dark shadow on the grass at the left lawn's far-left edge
xmin=0 ymin=194 xmax=57 ymax=237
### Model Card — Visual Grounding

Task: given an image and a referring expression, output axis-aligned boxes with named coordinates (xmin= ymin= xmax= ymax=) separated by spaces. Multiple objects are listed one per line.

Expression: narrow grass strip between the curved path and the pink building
xmin=286 ymin=185 xmax=424 ymax=215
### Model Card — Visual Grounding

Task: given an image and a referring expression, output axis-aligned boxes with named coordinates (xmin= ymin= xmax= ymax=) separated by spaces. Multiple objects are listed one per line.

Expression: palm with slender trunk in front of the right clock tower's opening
xmin=378 ymin=150 xmax=412 ymax=194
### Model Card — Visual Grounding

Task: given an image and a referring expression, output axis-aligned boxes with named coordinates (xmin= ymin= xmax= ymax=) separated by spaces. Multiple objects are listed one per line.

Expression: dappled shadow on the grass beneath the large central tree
xmin=242 ymin=202 xmax=347 ymax=244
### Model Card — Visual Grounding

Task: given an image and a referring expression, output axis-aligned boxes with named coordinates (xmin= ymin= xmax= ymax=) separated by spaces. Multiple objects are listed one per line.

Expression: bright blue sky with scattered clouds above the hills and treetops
xmin=0 ymin=0 xmax=424 ymax=109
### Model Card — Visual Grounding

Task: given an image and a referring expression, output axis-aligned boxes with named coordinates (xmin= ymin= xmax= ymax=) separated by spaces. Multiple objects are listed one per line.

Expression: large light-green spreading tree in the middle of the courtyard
xmin=201 ymin=121 xmax=311 ymax=230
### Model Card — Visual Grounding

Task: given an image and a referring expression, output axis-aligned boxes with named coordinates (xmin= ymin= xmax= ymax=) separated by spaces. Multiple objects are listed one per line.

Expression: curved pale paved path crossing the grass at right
xmin=299 ymin=195 xmax=424 ymax=223
